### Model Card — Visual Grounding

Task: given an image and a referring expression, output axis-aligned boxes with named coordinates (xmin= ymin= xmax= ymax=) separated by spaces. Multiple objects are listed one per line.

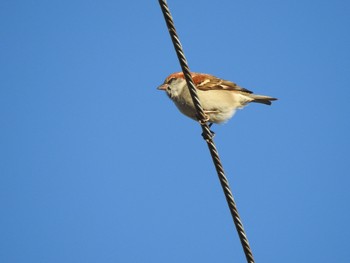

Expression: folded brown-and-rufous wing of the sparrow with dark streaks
xmin=192 ymin=74 xmax=253 ymax=93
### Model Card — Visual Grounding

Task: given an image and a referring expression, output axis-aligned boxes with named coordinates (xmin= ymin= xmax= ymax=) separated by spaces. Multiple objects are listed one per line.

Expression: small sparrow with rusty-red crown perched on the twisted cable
xmin=158 ymin=72 xmax=277 ymax=126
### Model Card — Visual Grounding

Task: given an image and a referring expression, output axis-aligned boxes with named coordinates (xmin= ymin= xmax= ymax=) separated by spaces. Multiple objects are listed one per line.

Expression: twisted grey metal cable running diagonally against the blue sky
xmin=159 ymin=0 xmax=254 ymax=263
